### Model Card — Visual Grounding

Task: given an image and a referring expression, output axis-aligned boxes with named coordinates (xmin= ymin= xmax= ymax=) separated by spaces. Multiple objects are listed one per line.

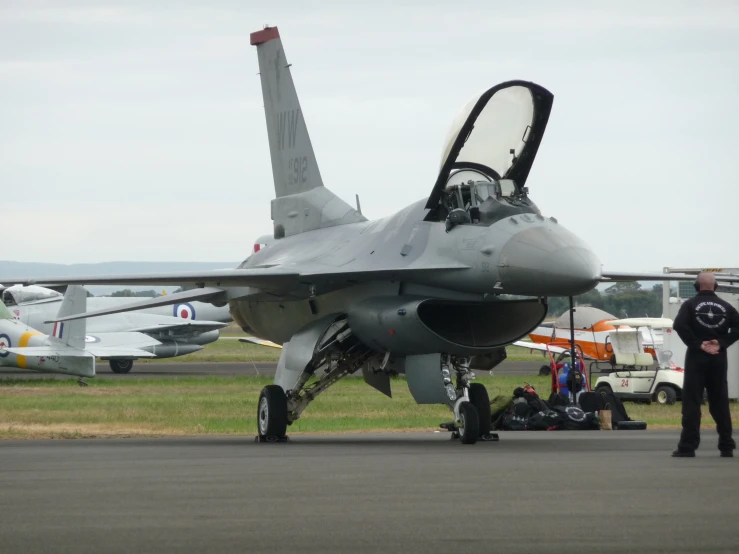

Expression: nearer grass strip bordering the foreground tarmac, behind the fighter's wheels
xmin=0 ymin=376 xmax=739 ymax=439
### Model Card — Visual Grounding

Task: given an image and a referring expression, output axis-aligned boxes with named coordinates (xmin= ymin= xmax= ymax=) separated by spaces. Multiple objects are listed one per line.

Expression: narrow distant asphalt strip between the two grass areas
xmin=0 ymin=361 xmax=542 ymax=380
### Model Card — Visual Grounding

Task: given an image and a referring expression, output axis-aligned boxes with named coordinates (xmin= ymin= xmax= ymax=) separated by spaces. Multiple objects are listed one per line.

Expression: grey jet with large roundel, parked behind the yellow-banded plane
xmin=2 ymin=285 xmax=231 ymax=373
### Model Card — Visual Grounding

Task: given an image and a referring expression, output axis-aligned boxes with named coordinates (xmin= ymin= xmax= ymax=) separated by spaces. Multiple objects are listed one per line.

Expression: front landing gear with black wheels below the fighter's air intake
xmin=440 ymin=356 xmax=499 ymax=444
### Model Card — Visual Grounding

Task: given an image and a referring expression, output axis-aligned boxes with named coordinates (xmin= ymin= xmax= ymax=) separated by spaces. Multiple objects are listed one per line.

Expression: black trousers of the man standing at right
xmin=678 ymin=350 xmax=736 ymax=451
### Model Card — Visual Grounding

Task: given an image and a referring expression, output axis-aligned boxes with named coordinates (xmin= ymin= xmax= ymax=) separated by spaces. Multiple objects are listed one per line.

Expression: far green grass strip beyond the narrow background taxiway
xmin=142 ymin=333 xmax=546 ymax=364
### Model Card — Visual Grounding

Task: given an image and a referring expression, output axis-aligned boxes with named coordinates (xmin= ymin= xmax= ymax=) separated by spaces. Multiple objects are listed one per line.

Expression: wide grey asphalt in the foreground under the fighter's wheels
xmin=0 ymin=431 xmax=739 ymax=554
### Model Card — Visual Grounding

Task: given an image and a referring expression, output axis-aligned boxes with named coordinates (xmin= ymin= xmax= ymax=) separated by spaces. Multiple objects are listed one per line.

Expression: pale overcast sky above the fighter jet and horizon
xmin=0 ymin=0 xmax=739 ymax=271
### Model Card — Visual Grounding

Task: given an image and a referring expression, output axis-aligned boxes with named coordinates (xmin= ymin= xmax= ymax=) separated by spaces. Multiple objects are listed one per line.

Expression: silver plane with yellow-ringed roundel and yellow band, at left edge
xmin=0 ymin=285 xmax=158 ymax=377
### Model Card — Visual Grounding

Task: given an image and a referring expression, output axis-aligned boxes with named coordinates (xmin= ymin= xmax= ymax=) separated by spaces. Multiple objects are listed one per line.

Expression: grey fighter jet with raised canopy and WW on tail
xmin=7 ymin=27 xmax=739 ymax=444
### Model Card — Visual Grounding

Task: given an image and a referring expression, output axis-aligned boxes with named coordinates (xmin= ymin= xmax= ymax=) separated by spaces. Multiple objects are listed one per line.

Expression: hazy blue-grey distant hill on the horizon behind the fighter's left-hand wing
xmin=0 ymin=260 xmax=240 ymax=296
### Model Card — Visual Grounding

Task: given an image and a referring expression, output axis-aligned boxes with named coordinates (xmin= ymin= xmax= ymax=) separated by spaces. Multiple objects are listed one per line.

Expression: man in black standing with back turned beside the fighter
xmin=672 ymin=272 xmax=739 ymax=458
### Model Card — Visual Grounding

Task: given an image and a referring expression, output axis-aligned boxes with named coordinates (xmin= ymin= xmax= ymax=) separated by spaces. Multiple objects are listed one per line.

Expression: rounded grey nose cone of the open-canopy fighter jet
xmin=500 ymin=224 xmax=601 ymax=296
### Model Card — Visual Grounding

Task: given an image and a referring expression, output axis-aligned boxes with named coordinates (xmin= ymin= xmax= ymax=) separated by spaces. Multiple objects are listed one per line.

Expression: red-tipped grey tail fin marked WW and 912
xmin=251 ymin=27 xmax=323 ymax=198
